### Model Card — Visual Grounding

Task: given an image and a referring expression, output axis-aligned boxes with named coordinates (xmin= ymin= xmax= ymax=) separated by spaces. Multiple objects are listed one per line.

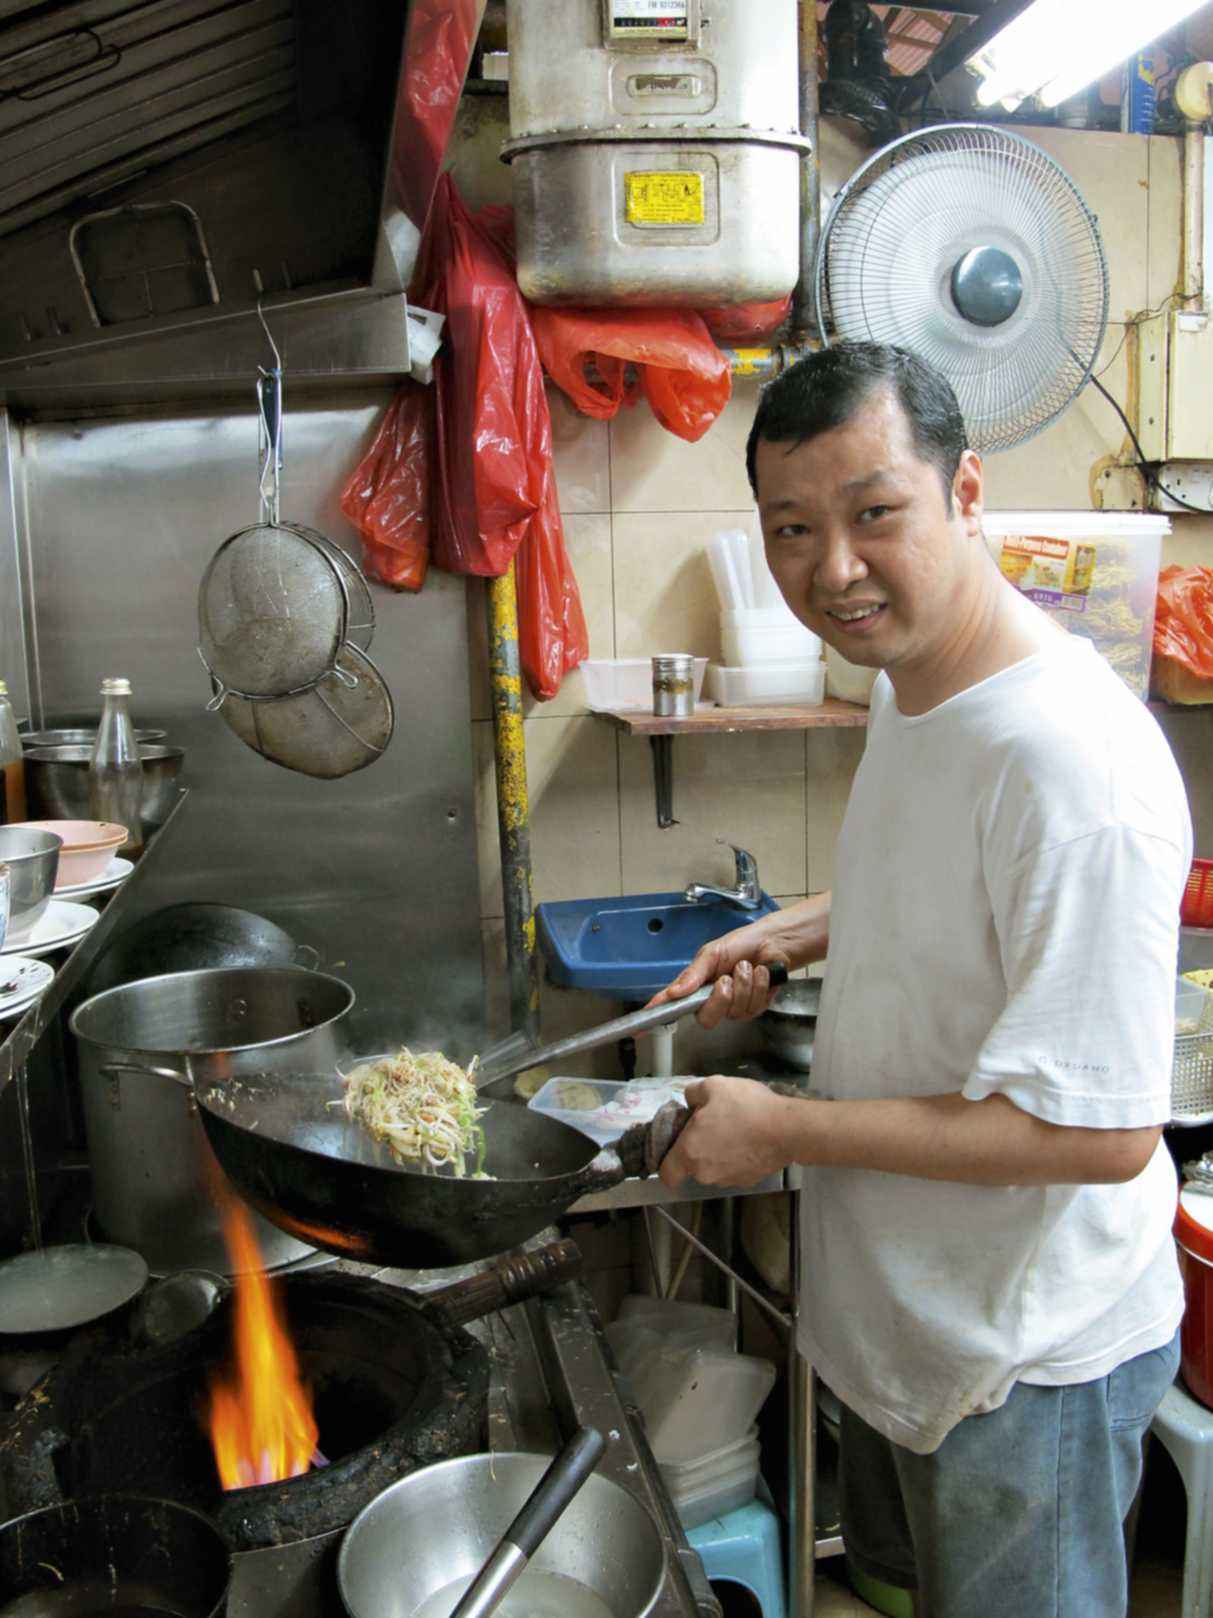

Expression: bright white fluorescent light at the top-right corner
xmin=969 ymin=0 xmax=1205 ymax=110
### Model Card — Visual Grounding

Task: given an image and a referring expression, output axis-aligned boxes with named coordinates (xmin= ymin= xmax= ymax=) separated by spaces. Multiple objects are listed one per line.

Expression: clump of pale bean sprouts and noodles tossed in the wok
xmin=344 ymin=1048 xmax=490 ymax=1180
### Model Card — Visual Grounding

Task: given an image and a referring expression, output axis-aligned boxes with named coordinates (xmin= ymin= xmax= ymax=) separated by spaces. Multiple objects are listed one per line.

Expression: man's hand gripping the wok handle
xmin=660 ymin=1074 xmax=792 ymax=1191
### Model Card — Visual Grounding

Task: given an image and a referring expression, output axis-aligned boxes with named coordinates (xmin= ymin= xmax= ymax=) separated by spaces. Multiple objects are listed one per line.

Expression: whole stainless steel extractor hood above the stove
xmin=0 ymin=0 xmax=411 ymax=413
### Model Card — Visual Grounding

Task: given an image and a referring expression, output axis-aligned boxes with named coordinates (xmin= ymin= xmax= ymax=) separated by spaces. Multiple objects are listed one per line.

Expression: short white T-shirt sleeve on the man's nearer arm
xmin=964 ymin=825 xmax=1187 ymax=1129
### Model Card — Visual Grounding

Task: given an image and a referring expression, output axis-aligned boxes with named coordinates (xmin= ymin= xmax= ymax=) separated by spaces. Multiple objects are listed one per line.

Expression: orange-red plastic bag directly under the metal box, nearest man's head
xmin=530 ymin=304 xmax=733 ymax=443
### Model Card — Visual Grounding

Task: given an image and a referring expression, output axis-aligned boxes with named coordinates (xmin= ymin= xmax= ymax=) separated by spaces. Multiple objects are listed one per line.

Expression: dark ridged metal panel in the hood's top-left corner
xmin=0 ymin=0 xmax=299 ymax=236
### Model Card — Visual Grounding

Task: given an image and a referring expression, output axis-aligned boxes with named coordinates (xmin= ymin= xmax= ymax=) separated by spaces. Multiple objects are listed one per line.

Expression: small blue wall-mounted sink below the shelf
xmin=535 ymin=893 xmax=780 ymax=1000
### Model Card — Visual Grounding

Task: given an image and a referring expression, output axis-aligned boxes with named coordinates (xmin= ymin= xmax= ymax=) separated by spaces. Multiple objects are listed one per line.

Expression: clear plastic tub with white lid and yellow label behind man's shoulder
xmin=982 ymin=511 xmax=1171 ymax=699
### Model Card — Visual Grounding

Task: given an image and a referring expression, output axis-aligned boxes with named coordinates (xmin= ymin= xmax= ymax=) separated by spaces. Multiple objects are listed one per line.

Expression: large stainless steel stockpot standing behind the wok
xmin=71 ymin=968 xmax=354 ymax=1273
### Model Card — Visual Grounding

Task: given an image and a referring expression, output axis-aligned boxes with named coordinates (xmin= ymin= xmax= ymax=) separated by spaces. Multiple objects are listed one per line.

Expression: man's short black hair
xmin=746 ymin=343 xmax=969 ymax=500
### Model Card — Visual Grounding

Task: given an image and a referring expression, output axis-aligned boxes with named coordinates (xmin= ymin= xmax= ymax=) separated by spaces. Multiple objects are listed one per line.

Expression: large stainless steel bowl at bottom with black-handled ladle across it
xmin=336 ymin=1451 xmax=665 ymax=1618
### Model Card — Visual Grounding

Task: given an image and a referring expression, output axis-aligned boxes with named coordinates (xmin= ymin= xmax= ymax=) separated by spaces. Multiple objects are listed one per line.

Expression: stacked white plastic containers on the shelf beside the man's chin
xmin=707 ymin=529 xmax=825 ymax=707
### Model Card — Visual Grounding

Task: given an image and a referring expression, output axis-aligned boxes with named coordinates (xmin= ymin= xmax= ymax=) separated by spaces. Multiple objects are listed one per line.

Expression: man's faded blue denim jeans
xmin=841 ymin=1336 xmax=1179 ymax=1618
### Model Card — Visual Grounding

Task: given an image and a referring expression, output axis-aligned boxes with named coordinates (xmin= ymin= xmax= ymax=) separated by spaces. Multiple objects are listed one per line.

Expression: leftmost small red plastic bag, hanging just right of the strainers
xmin=341 ymin=382 xmax=433 ymax=591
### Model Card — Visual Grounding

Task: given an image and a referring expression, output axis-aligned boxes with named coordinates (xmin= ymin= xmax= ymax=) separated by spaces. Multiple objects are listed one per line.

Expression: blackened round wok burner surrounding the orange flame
xmin=0 ymin=1273 xmax=488 ymax=1550
